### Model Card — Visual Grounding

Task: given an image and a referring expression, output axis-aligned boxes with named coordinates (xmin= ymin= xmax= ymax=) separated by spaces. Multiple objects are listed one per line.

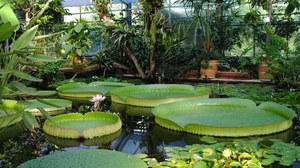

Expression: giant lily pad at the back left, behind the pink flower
xmin=56 ymin=82 xmax=133 ymax=104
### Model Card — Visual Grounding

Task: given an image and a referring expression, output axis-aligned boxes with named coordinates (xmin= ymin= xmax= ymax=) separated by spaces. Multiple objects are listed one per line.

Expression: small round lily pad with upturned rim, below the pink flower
xmin=43 ymin=112 xmax=122 ymax=139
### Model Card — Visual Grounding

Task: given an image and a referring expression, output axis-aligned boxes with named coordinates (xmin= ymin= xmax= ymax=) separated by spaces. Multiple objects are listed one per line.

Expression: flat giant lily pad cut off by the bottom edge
xmin=18 ymin=149 xmax=147 ymax=168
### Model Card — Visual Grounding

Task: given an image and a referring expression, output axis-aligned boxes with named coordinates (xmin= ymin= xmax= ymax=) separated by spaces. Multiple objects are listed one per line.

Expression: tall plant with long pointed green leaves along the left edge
xmin=0 ymin=0 xmax=59 ymax=130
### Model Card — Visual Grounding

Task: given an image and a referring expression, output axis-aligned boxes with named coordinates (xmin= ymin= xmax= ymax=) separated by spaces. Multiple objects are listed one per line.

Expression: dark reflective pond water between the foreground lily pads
xmin=0 ymin=101 xmax=300 ymax=167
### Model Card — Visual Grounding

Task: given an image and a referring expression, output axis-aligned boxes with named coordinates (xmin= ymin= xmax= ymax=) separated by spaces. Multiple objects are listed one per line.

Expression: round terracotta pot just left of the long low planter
xmin=200 ymin=60 xmax=219 ymax=78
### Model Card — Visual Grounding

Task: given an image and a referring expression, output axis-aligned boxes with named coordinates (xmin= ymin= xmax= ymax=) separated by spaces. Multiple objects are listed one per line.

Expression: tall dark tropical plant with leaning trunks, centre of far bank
xmin=98 ymin=0 xmax=188 ymax=79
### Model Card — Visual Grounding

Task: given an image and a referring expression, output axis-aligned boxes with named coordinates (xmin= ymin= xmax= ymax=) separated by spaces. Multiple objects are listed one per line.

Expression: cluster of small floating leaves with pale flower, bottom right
xmin=149 ymin=138 xmax=300 ymax=168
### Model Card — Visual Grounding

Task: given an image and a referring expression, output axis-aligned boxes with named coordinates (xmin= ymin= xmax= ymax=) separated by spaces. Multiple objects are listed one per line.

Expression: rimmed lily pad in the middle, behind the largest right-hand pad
xmin=109 ymin=84 xmax=210 ymax=107
